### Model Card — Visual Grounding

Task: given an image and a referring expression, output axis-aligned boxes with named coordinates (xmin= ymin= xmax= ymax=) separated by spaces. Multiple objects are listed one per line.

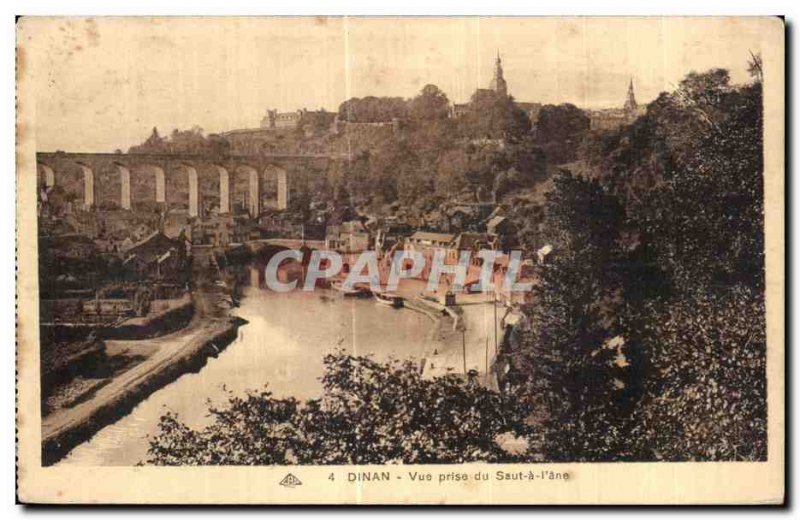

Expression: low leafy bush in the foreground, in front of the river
xmin=147 ymin=355 xmax=532 ymax=465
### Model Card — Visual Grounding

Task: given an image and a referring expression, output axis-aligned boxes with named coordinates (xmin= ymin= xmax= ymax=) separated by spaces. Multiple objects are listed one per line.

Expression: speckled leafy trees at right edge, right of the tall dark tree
xmin=630 ymin=70 xmax=767 ymax=460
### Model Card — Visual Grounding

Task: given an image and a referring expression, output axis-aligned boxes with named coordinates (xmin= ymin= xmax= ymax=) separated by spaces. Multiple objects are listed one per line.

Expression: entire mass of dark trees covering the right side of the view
xmin=514 ymin=63 xmax=767 ymax=460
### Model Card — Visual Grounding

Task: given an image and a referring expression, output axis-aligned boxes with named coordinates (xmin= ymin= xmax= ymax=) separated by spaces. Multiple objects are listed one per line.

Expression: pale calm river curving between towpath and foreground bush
xmin=59 ymin=287 xmax=438 ymax=466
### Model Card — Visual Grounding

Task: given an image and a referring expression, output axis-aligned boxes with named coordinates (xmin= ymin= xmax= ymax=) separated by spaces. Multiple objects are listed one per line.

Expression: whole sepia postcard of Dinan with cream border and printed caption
xmin=16 ymin=17 xmax=785 ymax=505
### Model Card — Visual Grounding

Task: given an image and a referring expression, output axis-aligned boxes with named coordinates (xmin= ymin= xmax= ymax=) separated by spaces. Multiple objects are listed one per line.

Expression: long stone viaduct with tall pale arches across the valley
xmin=36 ymin=152 xmax=339 ymax=218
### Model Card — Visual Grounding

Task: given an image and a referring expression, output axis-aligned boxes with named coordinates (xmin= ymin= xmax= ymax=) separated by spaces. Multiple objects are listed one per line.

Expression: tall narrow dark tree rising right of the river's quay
xmin=517 ymin=172 xmax=630 ymax=460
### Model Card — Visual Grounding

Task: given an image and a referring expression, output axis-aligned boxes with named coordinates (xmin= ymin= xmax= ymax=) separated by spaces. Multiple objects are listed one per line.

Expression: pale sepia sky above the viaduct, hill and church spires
xmin=17 ymin=17 xmax=769 ymax=152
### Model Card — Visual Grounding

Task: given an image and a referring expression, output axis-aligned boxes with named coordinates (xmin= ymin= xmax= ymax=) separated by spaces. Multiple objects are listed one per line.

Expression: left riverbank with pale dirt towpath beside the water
xmin=42 ymin=289 xmax=245 ymax=465
